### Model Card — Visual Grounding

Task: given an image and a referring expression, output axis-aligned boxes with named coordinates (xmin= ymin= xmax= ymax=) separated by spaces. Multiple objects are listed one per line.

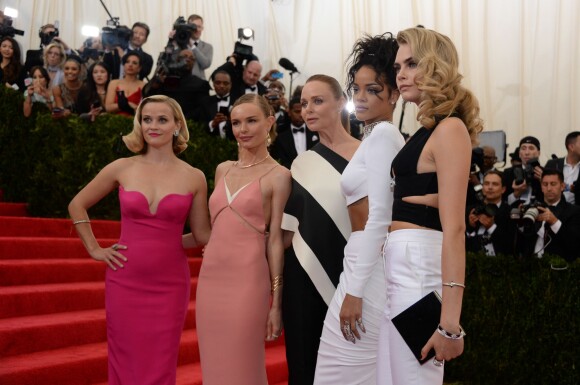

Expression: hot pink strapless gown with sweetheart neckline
xmin=105 ymin=187 xmax=193 ymax=385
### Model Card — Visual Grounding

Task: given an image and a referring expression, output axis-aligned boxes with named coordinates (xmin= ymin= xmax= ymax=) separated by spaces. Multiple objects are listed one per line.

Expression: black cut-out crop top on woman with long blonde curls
xmin=391 ymin=127 xmax=441 ymax=231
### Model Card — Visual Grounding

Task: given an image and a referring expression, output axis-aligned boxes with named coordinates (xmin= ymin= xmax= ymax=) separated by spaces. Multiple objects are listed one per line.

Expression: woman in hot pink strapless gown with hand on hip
xmin=69 ymin=95 xmax=209 ymax=385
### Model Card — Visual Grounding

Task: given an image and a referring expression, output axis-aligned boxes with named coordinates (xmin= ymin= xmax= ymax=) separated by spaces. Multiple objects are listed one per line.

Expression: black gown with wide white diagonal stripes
xmin=282 ymin=143 xmax=351 ymax=385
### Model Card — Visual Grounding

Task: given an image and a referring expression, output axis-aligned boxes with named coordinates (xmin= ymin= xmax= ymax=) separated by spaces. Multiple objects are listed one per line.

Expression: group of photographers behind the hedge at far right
xmin=466 ymin=131 xmax=580 ymax=262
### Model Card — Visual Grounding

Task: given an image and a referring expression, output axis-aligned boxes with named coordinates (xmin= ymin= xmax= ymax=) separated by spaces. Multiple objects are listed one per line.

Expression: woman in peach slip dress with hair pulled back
xmin=196 ymin=94 xmax=291 ymax=385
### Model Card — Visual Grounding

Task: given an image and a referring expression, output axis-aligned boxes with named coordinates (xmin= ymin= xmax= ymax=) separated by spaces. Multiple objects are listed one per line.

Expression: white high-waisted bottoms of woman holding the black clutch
xmin=377 ymin=229 xmax=443 ymax=385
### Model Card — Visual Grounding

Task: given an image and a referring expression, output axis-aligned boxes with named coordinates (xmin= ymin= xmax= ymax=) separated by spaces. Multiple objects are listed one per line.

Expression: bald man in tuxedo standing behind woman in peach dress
xmin=218 ymin=53 xmax=267 ymax=102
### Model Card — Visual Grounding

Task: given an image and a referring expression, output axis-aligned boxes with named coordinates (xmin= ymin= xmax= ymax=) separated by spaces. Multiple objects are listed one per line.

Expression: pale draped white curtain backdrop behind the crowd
xmin=0 ymin=0 xmax=580 ymax=163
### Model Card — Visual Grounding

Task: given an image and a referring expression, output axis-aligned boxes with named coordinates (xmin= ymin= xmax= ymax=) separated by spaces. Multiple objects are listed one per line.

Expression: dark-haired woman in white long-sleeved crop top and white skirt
xmin=314 ymin=33 xmax=404 ymax=384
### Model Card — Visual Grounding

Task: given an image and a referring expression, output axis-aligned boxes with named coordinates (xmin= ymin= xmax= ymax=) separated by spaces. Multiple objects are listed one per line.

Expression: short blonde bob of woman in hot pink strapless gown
xmin=123 ymin=95 xmax=189 ymax=155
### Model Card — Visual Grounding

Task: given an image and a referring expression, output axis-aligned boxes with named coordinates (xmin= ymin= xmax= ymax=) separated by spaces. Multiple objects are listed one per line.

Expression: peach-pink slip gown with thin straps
xmin=195 ymin=178 xmax=270 ymax=385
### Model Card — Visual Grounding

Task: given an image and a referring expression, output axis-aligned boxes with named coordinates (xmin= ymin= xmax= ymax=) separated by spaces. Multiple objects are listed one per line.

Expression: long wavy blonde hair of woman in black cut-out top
xmin=397 ymin=28 xmax=483 ymax=143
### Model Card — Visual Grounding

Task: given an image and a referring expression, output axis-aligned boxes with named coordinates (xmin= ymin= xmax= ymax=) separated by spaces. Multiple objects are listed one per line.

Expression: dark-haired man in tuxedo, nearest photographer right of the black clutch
xmin=465 ymin=170 xmax=515 ymax=256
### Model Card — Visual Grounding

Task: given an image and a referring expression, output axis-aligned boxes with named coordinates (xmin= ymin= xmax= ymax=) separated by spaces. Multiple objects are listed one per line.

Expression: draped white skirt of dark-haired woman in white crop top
xmin=314 ymin=231 xmax=386 ymax=385
